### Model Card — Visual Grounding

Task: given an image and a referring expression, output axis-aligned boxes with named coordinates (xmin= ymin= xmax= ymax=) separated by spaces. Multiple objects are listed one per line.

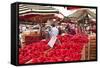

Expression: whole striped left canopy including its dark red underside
xmin=19 ymin=4 xmax=59 ymax=23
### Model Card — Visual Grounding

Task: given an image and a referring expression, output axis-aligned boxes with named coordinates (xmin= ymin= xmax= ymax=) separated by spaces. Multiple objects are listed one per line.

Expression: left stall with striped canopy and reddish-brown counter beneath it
xmin=19 ymin=4 xmax=60 ymax=45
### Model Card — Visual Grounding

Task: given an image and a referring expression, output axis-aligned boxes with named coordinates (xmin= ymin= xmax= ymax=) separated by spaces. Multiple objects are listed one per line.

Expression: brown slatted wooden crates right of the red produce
xmin=85 ymin=36 xmax=96 ymax=60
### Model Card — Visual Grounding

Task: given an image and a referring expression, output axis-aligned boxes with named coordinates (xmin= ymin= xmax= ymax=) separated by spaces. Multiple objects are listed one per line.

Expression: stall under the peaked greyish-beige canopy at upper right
xmin=67 ymin=8 xmax=96 ymax=34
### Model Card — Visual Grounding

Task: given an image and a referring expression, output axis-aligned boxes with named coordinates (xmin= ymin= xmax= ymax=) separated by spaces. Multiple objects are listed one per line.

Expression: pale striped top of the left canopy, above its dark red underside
xmin=19 ymin=4 xmax=59 ymax=15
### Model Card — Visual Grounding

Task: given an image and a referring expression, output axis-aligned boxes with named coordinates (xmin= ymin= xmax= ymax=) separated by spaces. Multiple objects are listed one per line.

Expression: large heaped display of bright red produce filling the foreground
xmin=19 ymin=34 xmax=89 ymax=64
